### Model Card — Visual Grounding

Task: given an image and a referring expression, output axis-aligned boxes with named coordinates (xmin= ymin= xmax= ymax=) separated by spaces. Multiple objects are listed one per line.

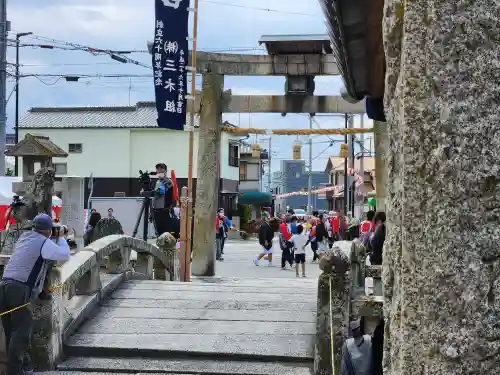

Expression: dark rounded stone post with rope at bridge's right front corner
xmin=314 ymin=248 xmax=351 ymax=375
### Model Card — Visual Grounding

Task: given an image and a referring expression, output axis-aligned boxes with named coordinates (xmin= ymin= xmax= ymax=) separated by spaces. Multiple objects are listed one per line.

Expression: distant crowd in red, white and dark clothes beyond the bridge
xmin=253 ymin=210 xmax=386 ymax=277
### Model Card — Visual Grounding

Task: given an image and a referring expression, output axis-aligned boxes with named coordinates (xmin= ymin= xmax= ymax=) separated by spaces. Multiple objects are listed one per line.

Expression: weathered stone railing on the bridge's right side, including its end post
xmin=314 ymin=241 xmax=383 ymax=375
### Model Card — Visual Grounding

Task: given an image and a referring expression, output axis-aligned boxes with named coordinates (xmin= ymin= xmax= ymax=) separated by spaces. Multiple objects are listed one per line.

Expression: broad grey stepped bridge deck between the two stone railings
xmin=45 ymin=278 xmax=316 ymax=375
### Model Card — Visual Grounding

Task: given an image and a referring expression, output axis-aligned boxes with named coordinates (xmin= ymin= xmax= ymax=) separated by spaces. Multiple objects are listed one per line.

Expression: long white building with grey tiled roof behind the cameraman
xmin=19 ymin=102 xmax=244 ymax=216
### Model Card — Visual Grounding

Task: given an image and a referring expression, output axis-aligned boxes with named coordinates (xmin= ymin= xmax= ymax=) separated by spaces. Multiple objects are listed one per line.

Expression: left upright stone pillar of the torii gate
xmin=192 ymin=73 xmax=224 ymax=276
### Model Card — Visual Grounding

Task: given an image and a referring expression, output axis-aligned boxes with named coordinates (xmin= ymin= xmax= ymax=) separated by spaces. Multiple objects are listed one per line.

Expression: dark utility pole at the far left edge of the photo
xmin=0 ymin=0 xmax=9 ymax=176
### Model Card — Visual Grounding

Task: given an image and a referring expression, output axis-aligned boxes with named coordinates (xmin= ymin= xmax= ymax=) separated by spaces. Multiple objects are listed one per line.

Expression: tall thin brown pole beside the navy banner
xmin=184 ymin=0 xmax=198 ymax=281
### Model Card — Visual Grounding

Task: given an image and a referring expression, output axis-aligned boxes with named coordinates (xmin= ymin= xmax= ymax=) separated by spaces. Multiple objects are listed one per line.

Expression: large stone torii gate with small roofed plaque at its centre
xmin=184 ymin=35 xmax=364 ymax=276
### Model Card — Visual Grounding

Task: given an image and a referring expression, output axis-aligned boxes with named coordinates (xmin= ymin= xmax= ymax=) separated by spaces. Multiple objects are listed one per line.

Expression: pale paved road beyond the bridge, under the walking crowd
xmin=215 ymin=239 xmax=320 ymax=279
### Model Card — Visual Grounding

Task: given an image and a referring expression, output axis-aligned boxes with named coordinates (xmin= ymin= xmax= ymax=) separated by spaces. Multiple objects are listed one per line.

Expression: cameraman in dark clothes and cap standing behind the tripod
xmin=153 ymin=163 xmax=180 ymax=238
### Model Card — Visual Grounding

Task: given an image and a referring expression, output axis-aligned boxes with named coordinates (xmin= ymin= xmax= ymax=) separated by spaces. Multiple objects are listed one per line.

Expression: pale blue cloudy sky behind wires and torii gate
xmin=3 ymin=0 xmax=369 ymax=184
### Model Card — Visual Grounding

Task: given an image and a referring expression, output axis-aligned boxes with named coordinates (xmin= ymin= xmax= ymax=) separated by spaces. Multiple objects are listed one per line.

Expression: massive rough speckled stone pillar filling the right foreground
xmin=382 ymin=0 xmax=500 ymax=375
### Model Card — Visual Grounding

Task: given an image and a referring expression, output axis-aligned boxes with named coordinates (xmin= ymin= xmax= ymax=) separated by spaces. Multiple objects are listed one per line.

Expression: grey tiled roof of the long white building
xmin=19 ymin=102 xmax=199 ymax=129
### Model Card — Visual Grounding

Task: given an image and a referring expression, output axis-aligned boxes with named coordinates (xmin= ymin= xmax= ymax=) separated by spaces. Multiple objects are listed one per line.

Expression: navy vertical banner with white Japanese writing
xmin=152 ymin=0 xmax=189 ymax=130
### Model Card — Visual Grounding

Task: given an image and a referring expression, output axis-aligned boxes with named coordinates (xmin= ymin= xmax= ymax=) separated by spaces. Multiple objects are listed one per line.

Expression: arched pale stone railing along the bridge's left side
xmin=0 ymin=234 xmax=179 ymax=371
